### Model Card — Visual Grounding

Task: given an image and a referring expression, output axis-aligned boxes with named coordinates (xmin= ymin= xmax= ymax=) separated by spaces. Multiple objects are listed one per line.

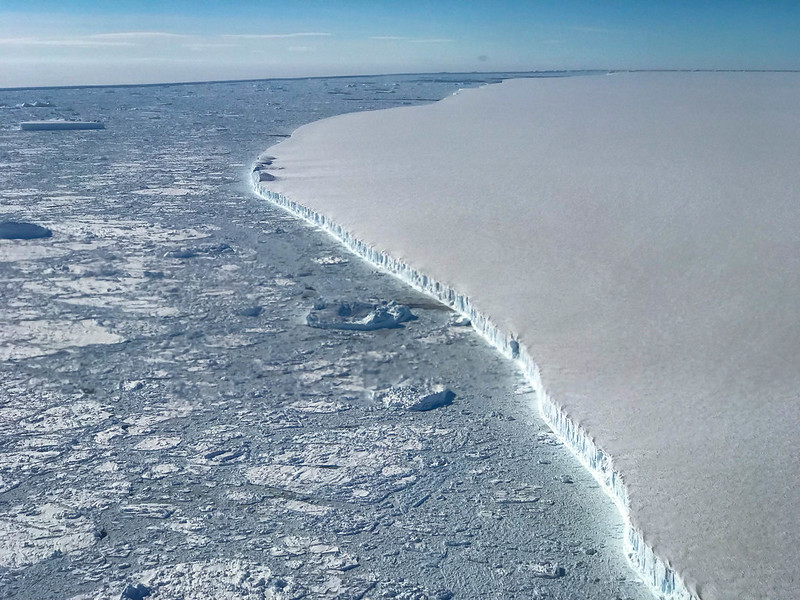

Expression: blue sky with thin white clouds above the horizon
xmin=0 ymin=0 xmax=800 ymax=87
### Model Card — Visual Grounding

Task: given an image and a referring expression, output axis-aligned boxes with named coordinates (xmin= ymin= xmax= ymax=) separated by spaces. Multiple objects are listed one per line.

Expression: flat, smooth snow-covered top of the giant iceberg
xmin=269 ymin=73 xmax=800 ymax=599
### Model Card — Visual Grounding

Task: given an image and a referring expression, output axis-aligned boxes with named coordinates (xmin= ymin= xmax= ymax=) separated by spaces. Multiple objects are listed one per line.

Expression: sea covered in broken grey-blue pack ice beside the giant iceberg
xmin=0 ymin=76 xmax=649 ymax=600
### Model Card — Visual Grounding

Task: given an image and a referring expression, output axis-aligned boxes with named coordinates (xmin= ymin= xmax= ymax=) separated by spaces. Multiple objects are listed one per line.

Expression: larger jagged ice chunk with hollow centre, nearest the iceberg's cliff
xmin=306 ymin=300 xmax=417 ymax=331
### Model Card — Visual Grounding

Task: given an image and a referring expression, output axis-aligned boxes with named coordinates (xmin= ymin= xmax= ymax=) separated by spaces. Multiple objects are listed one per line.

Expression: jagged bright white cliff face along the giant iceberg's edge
xmin=253 ymin=173 xmax=699 ymax=600
